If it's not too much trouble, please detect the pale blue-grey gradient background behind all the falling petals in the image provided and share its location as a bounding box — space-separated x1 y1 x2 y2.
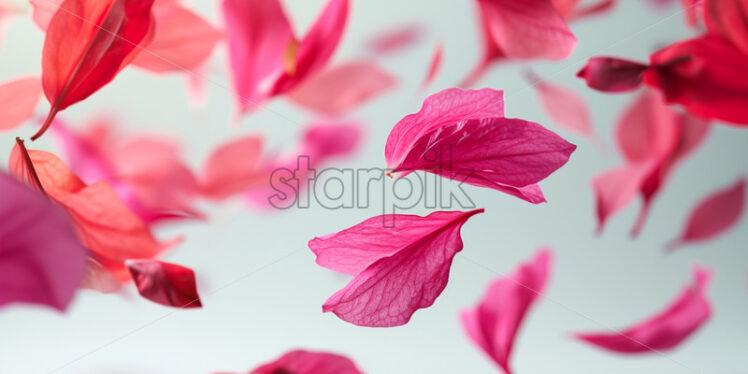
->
0 0 748 374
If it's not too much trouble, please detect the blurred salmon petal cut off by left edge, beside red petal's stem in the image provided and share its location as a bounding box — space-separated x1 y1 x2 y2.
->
0 77 42 130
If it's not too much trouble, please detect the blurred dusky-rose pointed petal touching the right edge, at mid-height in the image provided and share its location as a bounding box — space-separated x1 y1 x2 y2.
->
669 178 746 249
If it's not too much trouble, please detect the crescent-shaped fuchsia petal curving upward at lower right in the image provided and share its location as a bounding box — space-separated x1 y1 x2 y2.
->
576 267 712 354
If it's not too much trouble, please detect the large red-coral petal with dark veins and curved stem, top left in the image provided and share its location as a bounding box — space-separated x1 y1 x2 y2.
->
37 0 153 140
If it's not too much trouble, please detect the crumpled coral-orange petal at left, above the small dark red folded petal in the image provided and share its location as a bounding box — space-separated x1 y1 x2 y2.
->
8 146 165 280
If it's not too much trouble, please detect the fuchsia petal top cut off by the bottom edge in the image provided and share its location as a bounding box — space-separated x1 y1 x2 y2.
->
249 350 363 374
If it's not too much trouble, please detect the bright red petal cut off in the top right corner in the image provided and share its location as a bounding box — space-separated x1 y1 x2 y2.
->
703 0 748 54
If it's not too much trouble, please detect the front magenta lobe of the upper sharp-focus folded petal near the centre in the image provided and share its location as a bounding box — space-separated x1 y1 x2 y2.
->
393 118 576 202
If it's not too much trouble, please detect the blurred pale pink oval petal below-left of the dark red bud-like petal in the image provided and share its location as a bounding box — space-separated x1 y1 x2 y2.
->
531 71 597 140
